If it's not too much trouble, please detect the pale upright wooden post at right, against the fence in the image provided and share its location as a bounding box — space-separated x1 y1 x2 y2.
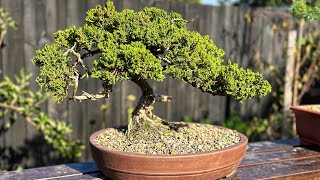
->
281 30 297 138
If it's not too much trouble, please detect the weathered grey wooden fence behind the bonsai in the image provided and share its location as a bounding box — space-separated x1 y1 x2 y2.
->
0 0 294 167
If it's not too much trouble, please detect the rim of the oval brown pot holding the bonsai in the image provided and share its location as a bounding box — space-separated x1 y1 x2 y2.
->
90 125 248 159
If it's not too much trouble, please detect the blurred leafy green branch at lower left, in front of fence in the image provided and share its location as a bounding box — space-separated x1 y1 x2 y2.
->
0 71 84 159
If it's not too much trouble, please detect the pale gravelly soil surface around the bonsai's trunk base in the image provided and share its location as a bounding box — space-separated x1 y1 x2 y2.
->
97 123 240 155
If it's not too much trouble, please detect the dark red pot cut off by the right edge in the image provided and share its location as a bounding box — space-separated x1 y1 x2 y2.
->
290 105 320 146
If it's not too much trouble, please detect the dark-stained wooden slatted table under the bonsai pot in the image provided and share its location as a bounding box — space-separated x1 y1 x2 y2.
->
0 139 320 180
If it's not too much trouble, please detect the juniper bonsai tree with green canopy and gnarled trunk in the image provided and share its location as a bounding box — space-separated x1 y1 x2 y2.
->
33 2 271 141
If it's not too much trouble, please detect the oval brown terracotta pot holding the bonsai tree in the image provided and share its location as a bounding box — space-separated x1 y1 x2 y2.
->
90 125 248 180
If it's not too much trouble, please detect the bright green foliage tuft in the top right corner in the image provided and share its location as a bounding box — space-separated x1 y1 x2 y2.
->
291 0 320 21
